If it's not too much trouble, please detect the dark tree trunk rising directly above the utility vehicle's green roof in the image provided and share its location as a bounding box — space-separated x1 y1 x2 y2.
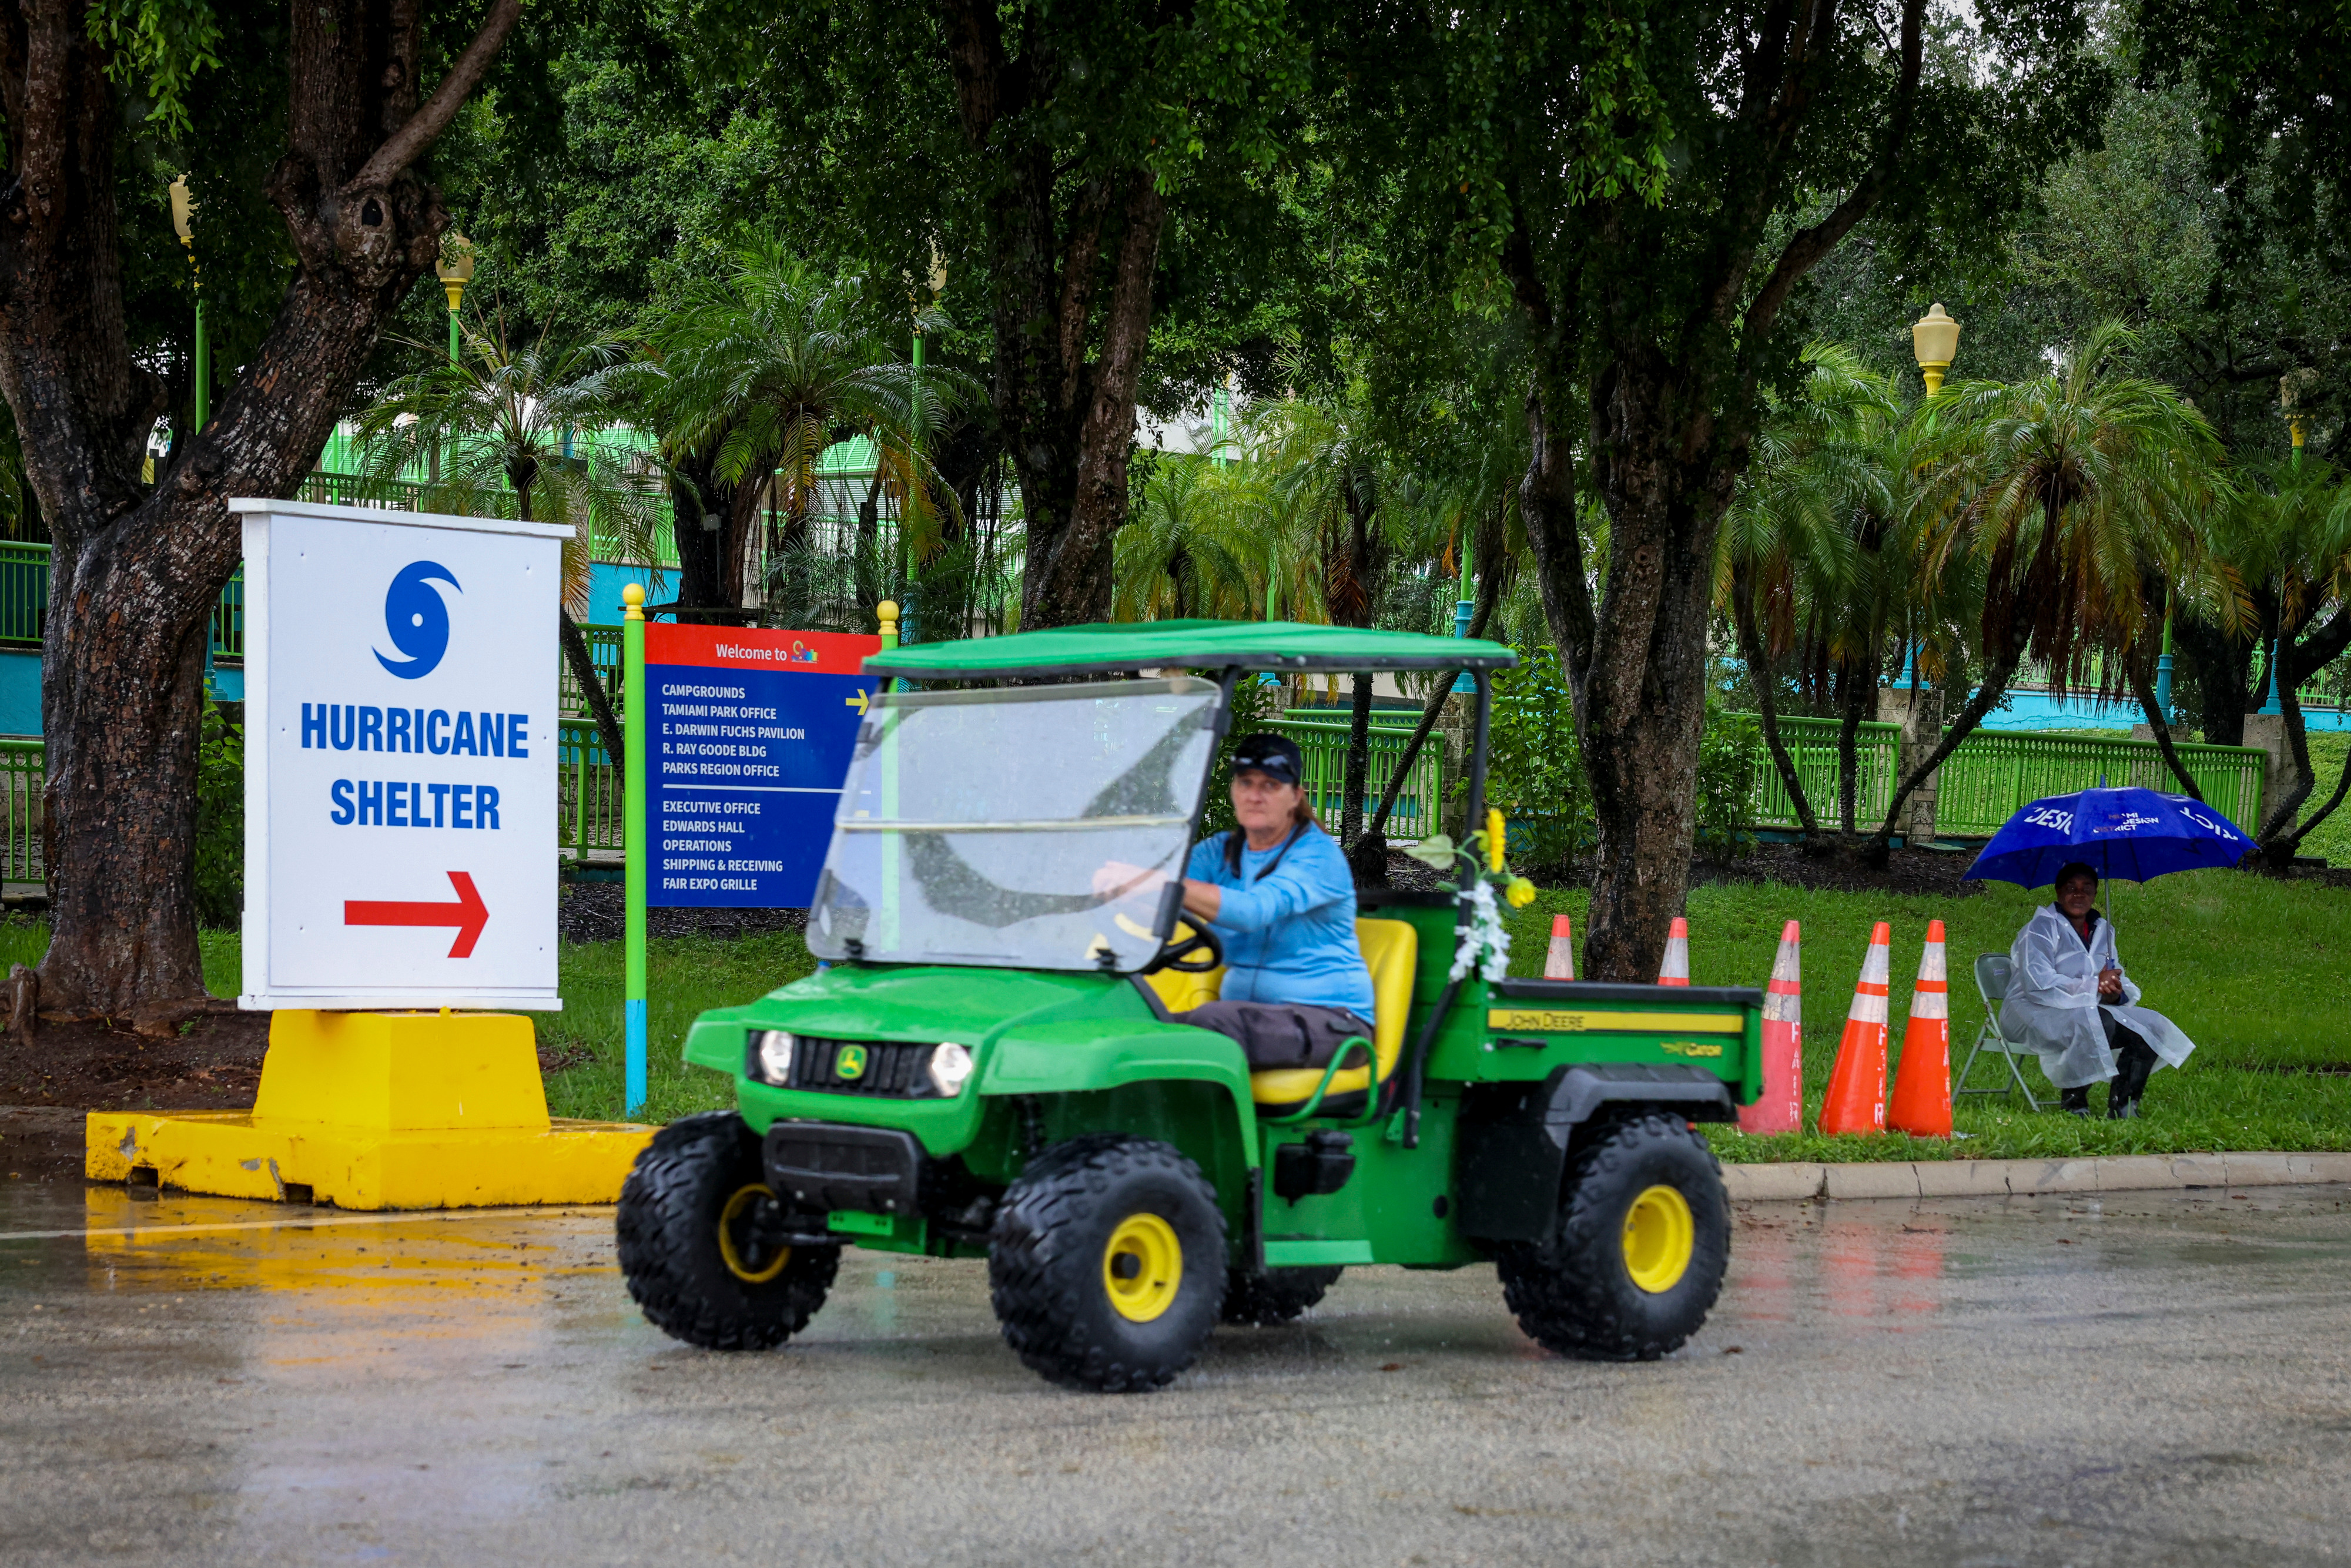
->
945 0 1166 630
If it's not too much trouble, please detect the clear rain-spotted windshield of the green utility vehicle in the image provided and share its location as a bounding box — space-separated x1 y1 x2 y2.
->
809 677 1223 973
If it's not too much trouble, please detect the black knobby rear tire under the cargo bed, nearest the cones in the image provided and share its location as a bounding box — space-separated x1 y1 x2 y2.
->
1495 1114 1730 1361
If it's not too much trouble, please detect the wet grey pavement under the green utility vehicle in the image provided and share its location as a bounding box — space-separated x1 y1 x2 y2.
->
0 1182 2351 1568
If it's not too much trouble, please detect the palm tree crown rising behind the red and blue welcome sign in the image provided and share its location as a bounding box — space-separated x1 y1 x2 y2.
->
628 242 978 618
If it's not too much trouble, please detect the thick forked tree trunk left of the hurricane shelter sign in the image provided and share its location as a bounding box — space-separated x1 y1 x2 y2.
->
0 0 520 1013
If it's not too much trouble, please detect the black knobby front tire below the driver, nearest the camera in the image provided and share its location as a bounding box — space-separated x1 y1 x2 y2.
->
987 1133 1225 1394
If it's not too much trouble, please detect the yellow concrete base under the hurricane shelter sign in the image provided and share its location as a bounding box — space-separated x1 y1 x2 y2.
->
85 1009 654 1208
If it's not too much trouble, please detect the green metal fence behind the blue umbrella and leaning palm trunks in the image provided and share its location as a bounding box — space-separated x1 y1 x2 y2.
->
1756 717 2266 837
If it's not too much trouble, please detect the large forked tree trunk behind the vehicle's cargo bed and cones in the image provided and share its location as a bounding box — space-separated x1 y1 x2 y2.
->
1500 0 1925 980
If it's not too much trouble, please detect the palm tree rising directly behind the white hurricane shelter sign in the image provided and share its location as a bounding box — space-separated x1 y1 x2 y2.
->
357 315 661 766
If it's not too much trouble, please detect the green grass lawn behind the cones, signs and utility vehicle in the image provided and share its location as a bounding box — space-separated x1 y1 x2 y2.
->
46 865 2351 1161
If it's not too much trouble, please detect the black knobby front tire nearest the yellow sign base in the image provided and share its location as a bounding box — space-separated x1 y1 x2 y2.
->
618 1110 842 1349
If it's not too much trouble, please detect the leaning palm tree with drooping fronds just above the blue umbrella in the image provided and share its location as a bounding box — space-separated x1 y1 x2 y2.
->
1869 322 2229 858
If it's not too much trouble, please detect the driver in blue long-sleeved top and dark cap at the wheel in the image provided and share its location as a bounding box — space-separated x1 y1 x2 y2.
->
1096 736 1373 1072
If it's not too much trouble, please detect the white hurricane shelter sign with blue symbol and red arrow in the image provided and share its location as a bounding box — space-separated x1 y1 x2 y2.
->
228 501 571 1011
